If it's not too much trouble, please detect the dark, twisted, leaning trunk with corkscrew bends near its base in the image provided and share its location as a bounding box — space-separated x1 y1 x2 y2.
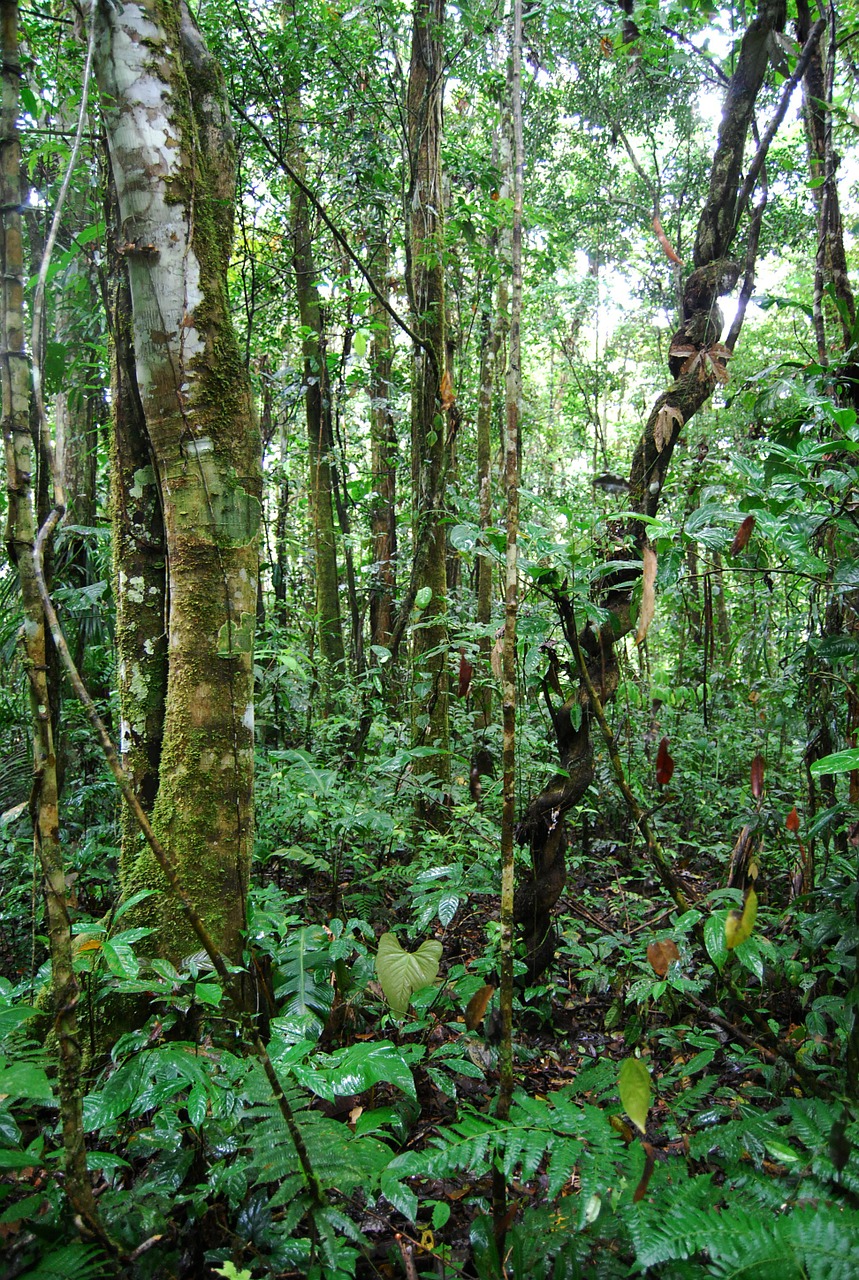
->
516 0 801 978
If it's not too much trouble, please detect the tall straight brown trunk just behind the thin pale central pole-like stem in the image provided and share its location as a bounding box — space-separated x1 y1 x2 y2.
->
407 0 452 820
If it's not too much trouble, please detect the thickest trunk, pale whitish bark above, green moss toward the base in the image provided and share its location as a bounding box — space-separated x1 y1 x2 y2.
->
96 0 261 957
